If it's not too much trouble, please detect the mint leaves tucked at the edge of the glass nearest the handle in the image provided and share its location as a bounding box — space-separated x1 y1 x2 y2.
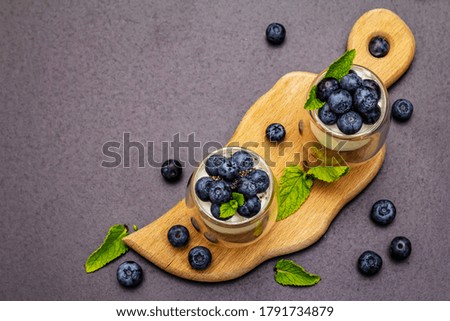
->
305 49 356 110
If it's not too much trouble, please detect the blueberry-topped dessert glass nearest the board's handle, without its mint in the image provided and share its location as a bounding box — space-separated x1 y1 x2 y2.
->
310 65 391 163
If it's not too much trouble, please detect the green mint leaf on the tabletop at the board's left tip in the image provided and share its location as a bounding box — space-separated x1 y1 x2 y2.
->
85 224 128 273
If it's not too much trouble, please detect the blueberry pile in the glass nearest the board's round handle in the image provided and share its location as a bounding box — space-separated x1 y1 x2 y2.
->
316 70 381 135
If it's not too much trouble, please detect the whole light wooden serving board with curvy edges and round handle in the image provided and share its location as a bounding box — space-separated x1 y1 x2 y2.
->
124 9 415 282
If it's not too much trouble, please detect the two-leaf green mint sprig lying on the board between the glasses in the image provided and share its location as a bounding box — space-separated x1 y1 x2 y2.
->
277 165 349 221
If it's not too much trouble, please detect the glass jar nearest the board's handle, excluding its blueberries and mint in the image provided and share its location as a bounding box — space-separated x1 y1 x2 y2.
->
308 65 391 165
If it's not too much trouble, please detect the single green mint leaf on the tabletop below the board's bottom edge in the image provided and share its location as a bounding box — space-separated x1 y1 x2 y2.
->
275 259 320 286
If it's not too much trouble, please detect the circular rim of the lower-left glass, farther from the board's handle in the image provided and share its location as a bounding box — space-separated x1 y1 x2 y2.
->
190 146 275 228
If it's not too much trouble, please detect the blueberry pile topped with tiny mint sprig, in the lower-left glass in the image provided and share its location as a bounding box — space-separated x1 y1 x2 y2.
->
195 150 270 220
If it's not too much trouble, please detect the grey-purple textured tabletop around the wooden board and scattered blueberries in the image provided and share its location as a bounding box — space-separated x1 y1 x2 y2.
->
0 0 450 300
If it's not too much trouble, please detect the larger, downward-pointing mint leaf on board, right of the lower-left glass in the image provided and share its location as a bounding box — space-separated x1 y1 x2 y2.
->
277 165 313 221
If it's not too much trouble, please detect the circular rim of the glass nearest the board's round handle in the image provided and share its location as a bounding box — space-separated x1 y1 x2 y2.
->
308 64 390 140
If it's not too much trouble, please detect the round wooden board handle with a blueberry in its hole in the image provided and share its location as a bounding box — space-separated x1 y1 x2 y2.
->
347 9 416 88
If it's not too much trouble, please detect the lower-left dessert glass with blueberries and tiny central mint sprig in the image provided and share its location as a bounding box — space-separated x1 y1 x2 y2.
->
186 147 277 247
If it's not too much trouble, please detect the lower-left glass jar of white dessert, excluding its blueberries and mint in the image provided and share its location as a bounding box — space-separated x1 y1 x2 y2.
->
185 147 277 247
